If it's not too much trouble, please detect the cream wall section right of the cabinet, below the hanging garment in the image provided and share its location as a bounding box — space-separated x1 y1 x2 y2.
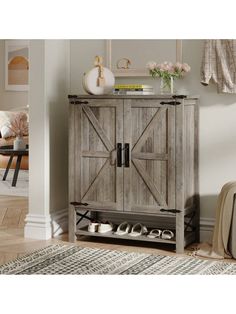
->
183 40 236 218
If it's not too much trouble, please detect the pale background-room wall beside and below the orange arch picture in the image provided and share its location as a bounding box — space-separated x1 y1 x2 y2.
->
0 40 28 110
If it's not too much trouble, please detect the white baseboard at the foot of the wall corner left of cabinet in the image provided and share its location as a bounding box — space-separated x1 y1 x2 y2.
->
24 214 52 240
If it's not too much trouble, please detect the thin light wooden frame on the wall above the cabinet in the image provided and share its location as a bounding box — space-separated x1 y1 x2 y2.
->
106 39 182 77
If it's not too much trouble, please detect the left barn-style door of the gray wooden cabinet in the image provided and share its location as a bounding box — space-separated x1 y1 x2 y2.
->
75 99 123 210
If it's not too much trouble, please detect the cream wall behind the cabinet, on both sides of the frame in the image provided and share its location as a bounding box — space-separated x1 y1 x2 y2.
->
70 40 236 226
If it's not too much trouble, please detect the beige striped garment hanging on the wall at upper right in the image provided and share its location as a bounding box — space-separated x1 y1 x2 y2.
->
201 39 236 93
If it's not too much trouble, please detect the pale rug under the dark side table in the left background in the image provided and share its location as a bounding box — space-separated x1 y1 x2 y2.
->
0 169 29 197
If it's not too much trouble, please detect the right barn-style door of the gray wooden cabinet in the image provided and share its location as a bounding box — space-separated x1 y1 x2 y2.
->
124 99 175 213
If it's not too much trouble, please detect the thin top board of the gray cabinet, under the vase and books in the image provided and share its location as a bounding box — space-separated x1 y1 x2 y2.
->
68 94 199 99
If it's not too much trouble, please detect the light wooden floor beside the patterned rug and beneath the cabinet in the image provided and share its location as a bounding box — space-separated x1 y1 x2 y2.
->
0 196 234 265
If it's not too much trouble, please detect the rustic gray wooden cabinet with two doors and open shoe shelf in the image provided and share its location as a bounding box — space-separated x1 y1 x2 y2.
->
69 95 199 253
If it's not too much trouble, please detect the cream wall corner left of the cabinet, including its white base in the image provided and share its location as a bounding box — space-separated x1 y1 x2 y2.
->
25 40 69 239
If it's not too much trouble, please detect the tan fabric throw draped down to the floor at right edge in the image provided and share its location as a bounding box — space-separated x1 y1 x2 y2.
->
196 181 236 258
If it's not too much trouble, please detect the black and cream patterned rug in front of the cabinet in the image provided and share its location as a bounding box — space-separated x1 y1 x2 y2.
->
0 245 236 275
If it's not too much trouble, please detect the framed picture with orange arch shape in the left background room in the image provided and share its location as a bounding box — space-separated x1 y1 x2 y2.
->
5 40 29 91
